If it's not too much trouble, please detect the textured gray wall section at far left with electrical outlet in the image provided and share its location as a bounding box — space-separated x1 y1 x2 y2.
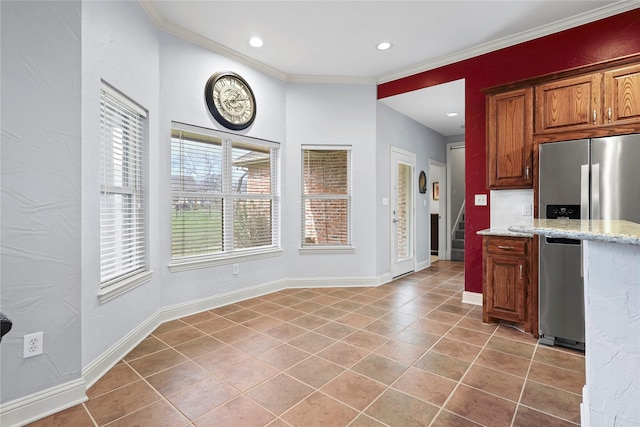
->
0 1 82 401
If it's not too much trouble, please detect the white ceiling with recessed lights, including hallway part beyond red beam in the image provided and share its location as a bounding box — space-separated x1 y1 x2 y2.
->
141 0 640 136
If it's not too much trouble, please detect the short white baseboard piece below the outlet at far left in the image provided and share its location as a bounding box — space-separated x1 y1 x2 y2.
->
0 378 88 427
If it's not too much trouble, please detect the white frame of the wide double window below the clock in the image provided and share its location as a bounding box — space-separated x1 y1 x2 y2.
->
169 122 282 272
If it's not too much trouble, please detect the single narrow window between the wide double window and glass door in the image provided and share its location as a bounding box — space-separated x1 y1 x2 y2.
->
302 146 351 248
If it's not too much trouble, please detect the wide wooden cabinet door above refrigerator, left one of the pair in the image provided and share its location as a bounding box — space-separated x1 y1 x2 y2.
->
535 73 604 133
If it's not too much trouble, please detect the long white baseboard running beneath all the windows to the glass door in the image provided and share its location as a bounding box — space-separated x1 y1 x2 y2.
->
0 273 420 427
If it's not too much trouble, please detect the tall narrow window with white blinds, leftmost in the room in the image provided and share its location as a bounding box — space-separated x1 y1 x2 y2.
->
100 83 147 288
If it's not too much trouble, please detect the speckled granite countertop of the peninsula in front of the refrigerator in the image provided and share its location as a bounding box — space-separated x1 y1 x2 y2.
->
509 219 640 245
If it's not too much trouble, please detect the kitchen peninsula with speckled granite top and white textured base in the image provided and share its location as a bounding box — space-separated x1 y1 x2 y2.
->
509 219 640 427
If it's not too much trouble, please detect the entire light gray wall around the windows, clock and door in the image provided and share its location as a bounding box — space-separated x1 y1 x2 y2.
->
0 1 444 414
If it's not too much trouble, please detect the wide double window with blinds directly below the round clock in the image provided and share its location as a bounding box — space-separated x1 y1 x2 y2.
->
171 123 280 262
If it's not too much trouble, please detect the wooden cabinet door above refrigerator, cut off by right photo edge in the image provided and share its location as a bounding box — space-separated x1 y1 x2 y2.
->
604 64 640 124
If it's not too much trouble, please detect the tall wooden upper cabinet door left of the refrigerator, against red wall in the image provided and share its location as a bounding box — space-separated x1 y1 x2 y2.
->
487 88 533 189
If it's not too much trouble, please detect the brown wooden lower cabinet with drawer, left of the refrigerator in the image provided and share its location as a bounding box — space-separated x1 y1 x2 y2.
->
482 236 537 336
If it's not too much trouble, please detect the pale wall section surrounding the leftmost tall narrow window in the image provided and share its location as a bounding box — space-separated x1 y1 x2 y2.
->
78 1 167 367
